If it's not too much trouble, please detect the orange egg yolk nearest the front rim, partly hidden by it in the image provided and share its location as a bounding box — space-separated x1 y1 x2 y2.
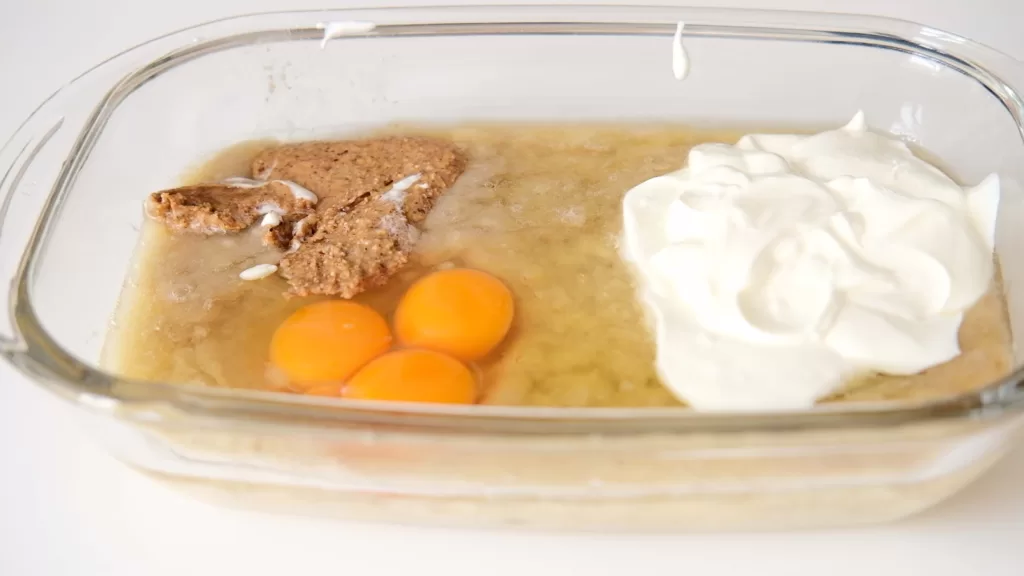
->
342 349 476 404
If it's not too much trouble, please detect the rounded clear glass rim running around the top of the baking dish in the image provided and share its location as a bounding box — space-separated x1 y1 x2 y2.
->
6 5 1024 435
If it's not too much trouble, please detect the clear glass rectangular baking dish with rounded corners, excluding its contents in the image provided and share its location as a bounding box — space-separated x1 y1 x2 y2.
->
0 6 1024 530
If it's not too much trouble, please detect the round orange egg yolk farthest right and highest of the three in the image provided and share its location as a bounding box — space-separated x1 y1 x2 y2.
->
394 269 514 361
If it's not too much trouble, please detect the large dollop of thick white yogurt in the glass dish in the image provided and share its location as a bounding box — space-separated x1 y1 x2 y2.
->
623 113 999 410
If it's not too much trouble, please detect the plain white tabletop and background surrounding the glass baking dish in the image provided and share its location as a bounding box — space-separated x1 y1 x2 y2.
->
0 0 1024 576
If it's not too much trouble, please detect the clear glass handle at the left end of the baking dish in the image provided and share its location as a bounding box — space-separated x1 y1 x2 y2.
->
0 104 63 358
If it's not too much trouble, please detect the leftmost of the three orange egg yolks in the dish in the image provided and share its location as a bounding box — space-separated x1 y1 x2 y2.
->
270 300 391 386
